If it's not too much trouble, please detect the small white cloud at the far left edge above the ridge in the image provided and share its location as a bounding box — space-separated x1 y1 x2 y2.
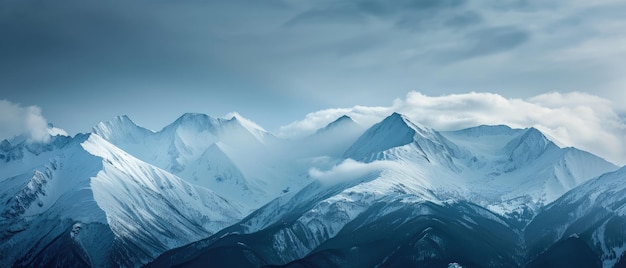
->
0 100 50 142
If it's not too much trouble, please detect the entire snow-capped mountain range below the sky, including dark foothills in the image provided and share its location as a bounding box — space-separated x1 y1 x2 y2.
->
0 113 626 267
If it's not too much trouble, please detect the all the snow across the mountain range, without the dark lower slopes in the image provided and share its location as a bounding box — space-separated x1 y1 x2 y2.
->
0 110 626 266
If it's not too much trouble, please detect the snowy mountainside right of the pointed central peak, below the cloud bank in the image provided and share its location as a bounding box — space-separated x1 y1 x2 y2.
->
442 126 617 222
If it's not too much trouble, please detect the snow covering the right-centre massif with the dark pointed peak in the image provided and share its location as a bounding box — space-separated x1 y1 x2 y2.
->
224 114 616 266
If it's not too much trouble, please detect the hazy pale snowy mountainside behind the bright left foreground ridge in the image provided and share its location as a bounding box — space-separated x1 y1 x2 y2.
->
93 113 307 212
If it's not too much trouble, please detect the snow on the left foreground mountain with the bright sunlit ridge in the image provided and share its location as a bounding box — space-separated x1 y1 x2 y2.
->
0 134 243 266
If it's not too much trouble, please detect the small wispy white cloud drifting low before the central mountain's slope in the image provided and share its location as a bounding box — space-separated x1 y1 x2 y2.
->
309 159 398 184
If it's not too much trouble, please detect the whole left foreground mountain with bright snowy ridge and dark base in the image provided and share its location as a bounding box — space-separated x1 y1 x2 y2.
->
0 134 242 267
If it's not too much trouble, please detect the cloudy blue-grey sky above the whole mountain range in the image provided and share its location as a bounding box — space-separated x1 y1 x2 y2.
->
0 0 626 164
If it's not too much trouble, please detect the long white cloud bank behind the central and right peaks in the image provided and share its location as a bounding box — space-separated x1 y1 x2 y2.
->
279 92 626 165
